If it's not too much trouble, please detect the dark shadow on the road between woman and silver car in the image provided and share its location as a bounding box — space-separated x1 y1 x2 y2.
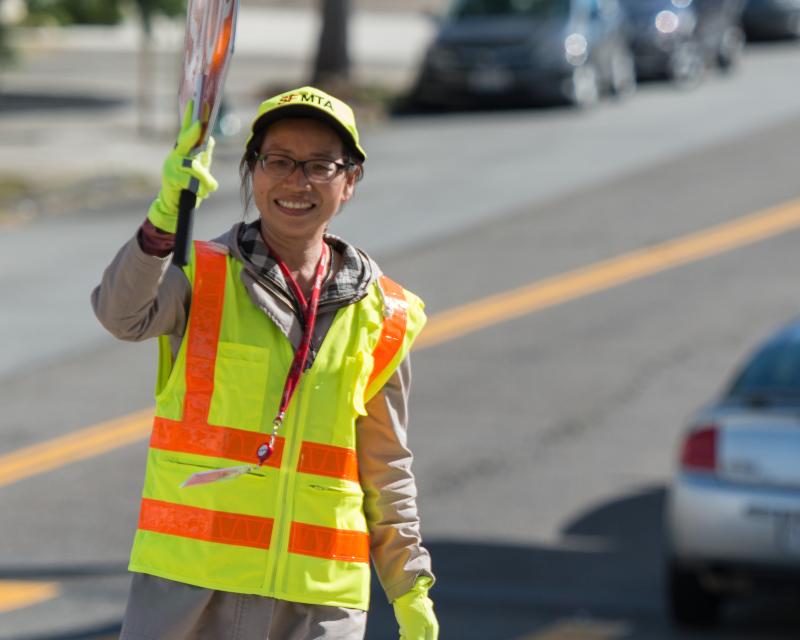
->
367 487 800 640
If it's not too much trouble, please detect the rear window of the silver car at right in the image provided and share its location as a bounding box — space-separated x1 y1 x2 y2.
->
728 341 800 396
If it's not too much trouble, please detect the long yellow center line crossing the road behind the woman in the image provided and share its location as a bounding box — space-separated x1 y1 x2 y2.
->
0 200 800 487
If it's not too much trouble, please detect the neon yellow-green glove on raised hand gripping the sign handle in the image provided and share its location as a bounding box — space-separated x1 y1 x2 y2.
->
147 102 219 233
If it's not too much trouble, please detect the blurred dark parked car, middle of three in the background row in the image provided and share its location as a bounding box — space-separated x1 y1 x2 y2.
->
622 0 745 85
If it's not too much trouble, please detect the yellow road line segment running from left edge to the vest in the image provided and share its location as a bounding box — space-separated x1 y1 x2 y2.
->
0 409 153 487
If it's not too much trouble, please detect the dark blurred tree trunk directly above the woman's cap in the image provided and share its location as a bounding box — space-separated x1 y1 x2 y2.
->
312 0 350 91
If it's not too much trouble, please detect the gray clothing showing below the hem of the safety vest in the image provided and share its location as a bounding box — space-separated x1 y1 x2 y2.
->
120 573 367 640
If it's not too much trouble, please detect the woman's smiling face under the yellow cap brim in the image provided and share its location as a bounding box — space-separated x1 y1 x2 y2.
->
253 118 356 241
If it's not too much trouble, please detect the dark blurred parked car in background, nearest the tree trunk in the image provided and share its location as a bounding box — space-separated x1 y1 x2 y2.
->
411 0 636 107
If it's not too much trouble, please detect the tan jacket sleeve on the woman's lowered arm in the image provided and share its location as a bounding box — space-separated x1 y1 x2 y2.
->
357 358 434 602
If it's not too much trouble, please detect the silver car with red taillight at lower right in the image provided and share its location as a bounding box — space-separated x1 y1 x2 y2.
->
665 320 800 625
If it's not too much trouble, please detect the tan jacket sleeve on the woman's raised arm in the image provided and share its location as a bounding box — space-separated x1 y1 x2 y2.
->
92 232 191 341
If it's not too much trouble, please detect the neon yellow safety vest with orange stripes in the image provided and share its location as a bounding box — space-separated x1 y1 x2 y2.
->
129 242 425 610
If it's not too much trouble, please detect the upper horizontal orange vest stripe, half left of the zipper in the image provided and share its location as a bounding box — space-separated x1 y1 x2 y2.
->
150 416 284 468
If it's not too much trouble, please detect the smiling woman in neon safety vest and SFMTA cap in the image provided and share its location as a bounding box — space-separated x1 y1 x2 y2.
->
92 87 438 640
